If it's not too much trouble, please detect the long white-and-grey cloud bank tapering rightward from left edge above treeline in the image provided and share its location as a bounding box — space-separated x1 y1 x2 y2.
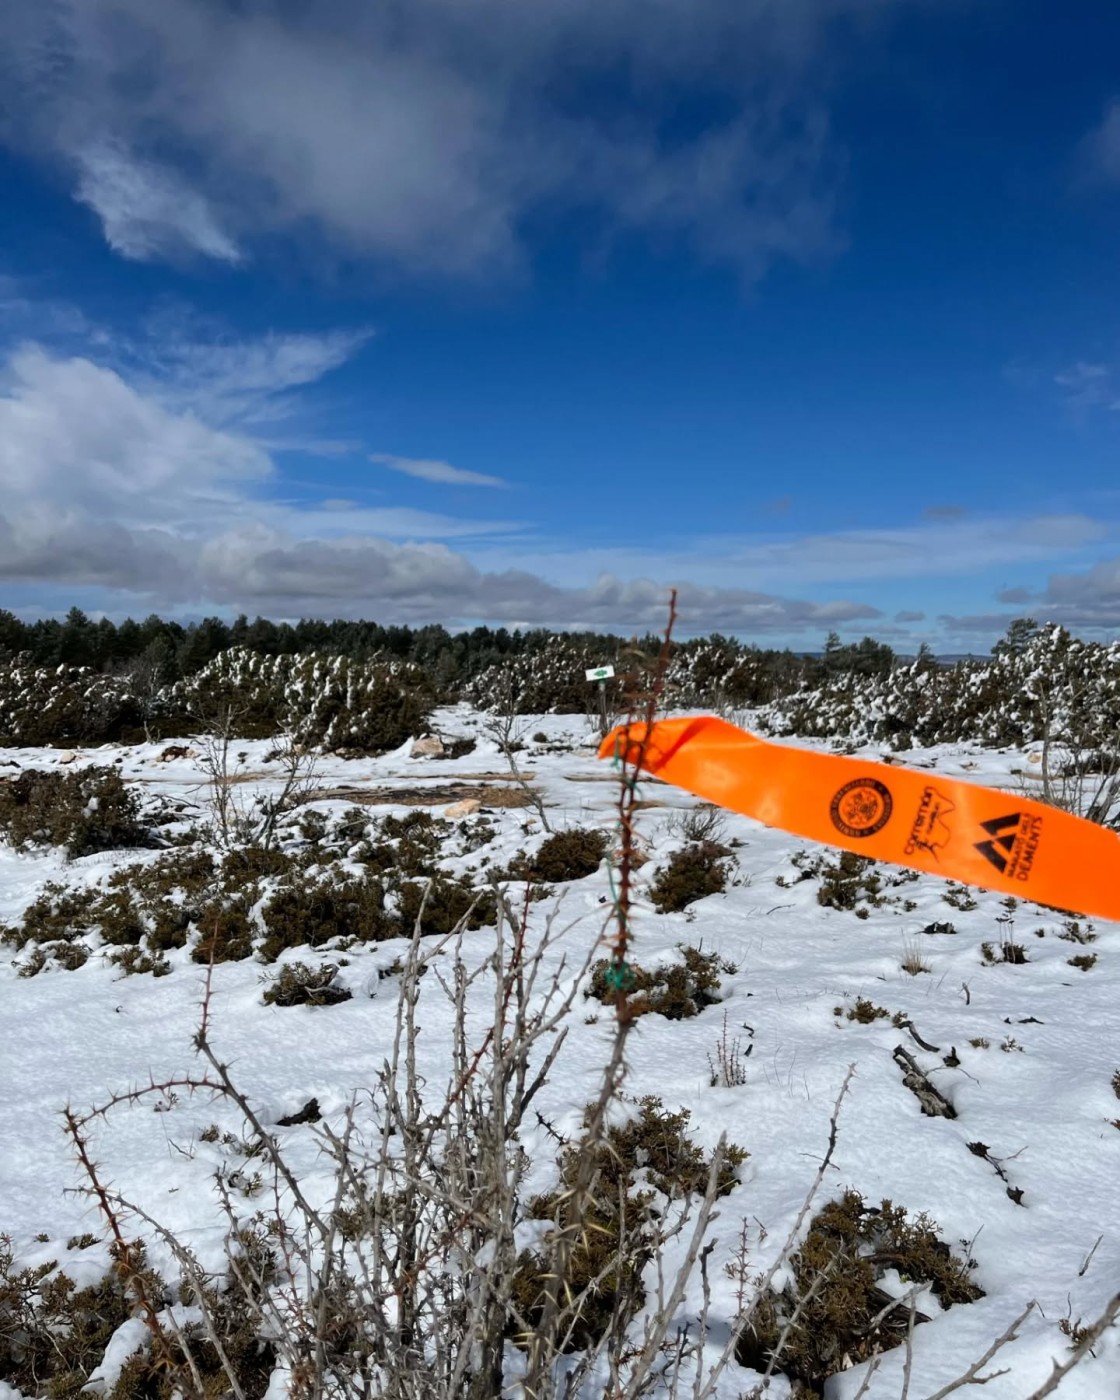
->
0 336 879 634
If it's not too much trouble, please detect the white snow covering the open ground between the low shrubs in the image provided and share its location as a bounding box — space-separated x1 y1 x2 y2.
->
0 708 1120 1400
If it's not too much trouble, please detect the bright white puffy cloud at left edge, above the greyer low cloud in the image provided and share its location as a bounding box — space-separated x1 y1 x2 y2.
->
0 337 518 543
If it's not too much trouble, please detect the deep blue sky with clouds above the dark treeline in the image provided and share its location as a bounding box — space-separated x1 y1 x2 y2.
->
0 0 1120 651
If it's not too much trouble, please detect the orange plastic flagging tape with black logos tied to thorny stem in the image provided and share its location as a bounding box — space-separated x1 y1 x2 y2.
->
599 715 1120 920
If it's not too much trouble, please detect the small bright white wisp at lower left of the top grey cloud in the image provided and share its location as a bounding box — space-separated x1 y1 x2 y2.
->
74 141 242 263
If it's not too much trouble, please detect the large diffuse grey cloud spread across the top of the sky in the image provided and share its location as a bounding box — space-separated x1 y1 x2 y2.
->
0 0 900 280
